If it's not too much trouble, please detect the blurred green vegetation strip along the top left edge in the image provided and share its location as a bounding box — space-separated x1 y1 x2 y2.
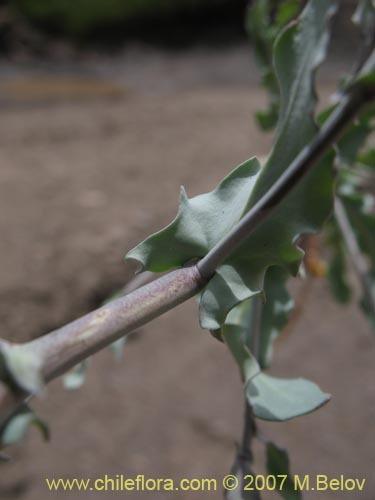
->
9 0 246 38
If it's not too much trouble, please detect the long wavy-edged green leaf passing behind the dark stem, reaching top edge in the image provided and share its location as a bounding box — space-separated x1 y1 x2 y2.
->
201 0 333 329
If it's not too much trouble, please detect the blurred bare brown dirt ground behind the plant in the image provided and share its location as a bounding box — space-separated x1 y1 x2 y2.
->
0 48 375 500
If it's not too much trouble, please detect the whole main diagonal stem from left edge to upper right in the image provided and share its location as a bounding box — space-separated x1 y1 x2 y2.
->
0 75 375 422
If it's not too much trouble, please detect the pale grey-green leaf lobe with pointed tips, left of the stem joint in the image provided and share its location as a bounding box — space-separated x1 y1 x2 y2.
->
126 158 260 272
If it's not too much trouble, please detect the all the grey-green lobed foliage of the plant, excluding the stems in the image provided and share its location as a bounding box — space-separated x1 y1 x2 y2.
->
0 4 375 500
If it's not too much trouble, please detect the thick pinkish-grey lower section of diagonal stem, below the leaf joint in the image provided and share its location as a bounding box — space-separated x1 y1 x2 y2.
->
0 266 206 420
